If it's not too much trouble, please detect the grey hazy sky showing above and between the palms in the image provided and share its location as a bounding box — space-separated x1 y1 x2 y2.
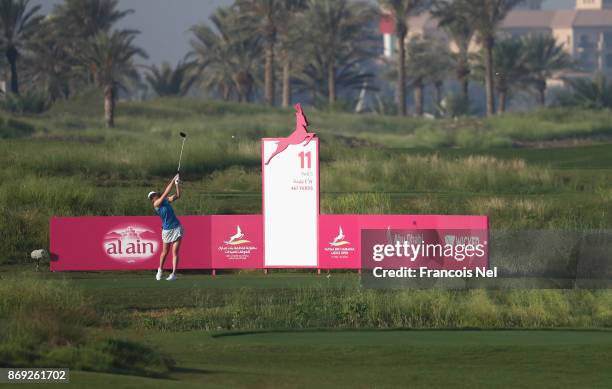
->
32 0 575 64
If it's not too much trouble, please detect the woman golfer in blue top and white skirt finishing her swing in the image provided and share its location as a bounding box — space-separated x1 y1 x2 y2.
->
147 174 183 281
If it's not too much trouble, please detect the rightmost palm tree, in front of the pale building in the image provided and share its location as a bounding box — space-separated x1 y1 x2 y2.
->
523 34 572 106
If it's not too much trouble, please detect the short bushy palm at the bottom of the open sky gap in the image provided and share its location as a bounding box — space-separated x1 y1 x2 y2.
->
145 62 195 96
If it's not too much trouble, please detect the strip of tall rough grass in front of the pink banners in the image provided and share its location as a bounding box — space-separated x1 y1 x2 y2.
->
129 288 612 331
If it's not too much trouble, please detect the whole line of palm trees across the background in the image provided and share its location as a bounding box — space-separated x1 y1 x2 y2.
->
0 0 610 126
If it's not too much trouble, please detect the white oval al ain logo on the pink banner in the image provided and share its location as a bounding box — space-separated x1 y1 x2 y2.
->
103 224 159 263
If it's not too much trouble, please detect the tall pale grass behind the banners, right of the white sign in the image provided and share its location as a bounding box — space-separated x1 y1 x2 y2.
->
321 154 556 193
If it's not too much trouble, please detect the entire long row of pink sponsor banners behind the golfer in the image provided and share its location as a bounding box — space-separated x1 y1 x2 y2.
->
50 215 488 271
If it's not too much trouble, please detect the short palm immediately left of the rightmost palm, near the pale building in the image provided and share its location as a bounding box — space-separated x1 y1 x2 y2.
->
493 39 528 114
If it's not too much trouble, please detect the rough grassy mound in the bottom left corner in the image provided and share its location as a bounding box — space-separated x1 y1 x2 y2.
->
0 277 173 376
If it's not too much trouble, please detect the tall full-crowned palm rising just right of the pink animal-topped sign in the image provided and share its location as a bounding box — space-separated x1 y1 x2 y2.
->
302 0 372 106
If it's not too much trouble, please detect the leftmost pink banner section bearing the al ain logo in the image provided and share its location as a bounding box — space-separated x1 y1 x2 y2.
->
50 216 211 271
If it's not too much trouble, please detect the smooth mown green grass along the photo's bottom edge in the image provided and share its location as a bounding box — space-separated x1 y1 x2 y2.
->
28 331 612 389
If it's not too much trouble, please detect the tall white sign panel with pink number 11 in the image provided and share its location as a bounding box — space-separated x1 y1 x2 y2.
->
262 138 319 267
